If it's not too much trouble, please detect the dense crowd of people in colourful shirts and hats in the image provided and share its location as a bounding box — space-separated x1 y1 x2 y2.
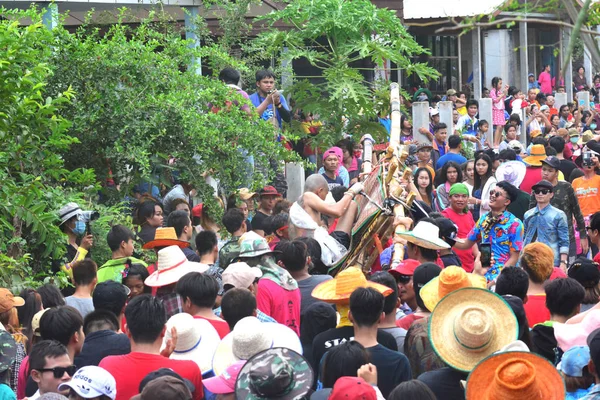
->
5 69 600 400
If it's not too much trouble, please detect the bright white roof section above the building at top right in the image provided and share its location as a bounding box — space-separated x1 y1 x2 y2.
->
404 0 505 20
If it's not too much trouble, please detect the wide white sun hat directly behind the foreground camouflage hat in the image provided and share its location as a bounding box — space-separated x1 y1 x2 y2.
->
212 317 302 376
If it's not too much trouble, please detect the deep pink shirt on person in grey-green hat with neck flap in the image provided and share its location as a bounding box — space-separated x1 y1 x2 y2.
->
256 278 302 336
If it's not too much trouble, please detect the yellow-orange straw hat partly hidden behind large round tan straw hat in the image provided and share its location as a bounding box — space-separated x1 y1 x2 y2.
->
419 265 487 311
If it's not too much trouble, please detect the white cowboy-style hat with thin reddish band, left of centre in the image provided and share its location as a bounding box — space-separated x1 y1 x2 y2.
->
144 246 208 287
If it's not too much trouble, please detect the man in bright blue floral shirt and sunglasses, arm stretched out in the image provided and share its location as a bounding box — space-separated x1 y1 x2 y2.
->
454 181 523 282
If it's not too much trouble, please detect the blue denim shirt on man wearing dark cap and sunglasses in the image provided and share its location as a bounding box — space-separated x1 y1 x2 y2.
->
523 204 569 266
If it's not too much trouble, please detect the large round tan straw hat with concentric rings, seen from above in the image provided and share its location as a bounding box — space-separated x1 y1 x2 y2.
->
429 288 519 372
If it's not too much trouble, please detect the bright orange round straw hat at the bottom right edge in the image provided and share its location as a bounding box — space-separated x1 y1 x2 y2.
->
466 352 566 400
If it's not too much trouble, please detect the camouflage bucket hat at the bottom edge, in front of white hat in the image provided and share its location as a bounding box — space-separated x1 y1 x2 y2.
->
235 347 314 400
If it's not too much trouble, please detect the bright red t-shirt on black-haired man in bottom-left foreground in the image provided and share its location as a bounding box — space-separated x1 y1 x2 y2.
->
99 352 204 400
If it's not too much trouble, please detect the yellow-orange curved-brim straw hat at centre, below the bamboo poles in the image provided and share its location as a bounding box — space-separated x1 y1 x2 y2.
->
311 267 392 303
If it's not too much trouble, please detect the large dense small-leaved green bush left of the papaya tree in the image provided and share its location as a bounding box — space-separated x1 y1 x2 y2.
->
44 9 286 200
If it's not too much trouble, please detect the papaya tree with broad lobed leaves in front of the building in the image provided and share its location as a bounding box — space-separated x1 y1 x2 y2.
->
252 0 438 143
